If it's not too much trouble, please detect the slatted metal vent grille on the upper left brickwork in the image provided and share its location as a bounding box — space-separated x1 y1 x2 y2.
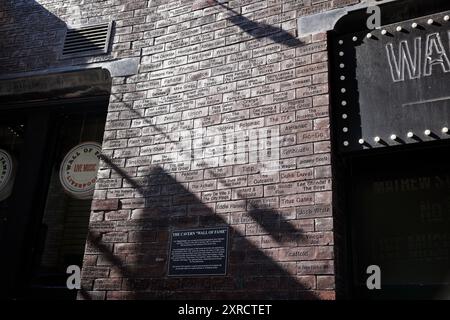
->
62 22 112 58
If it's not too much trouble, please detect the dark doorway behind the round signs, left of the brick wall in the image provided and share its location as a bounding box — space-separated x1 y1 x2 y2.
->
0 96 109 299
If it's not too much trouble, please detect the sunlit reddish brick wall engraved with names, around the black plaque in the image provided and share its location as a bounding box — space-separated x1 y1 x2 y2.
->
0 0 364 299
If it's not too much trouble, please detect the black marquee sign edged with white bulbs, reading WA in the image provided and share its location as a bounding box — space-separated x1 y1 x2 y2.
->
333 13 450 152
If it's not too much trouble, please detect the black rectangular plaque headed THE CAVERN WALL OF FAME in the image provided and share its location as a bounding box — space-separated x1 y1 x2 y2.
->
169 227 228 276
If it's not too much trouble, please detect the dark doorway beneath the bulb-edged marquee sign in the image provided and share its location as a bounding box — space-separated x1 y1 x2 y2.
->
347 143 450 299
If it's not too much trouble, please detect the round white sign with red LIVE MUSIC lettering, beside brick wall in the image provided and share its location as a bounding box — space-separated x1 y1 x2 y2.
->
59 142 102 199
